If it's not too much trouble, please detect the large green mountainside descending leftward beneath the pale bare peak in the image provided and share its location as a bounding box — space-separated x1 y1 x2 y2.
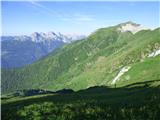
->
2 25 160 93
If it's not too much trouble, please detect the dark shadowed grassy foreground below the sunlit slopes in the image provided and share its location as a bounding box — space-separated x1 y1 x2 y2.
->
2 80 160 120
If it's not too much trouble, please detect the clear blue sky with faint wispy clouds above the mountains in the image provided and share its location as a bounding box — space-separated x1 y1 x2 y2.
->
1 1 160 35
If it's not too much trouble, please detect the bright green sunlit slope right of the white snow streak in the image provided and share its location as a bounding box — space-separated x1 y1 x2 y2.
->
116 56 160 86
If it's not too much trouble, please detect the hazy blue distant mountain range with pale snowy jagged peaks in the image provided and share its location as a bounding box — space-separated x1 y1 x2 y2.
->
1 32 85 68
